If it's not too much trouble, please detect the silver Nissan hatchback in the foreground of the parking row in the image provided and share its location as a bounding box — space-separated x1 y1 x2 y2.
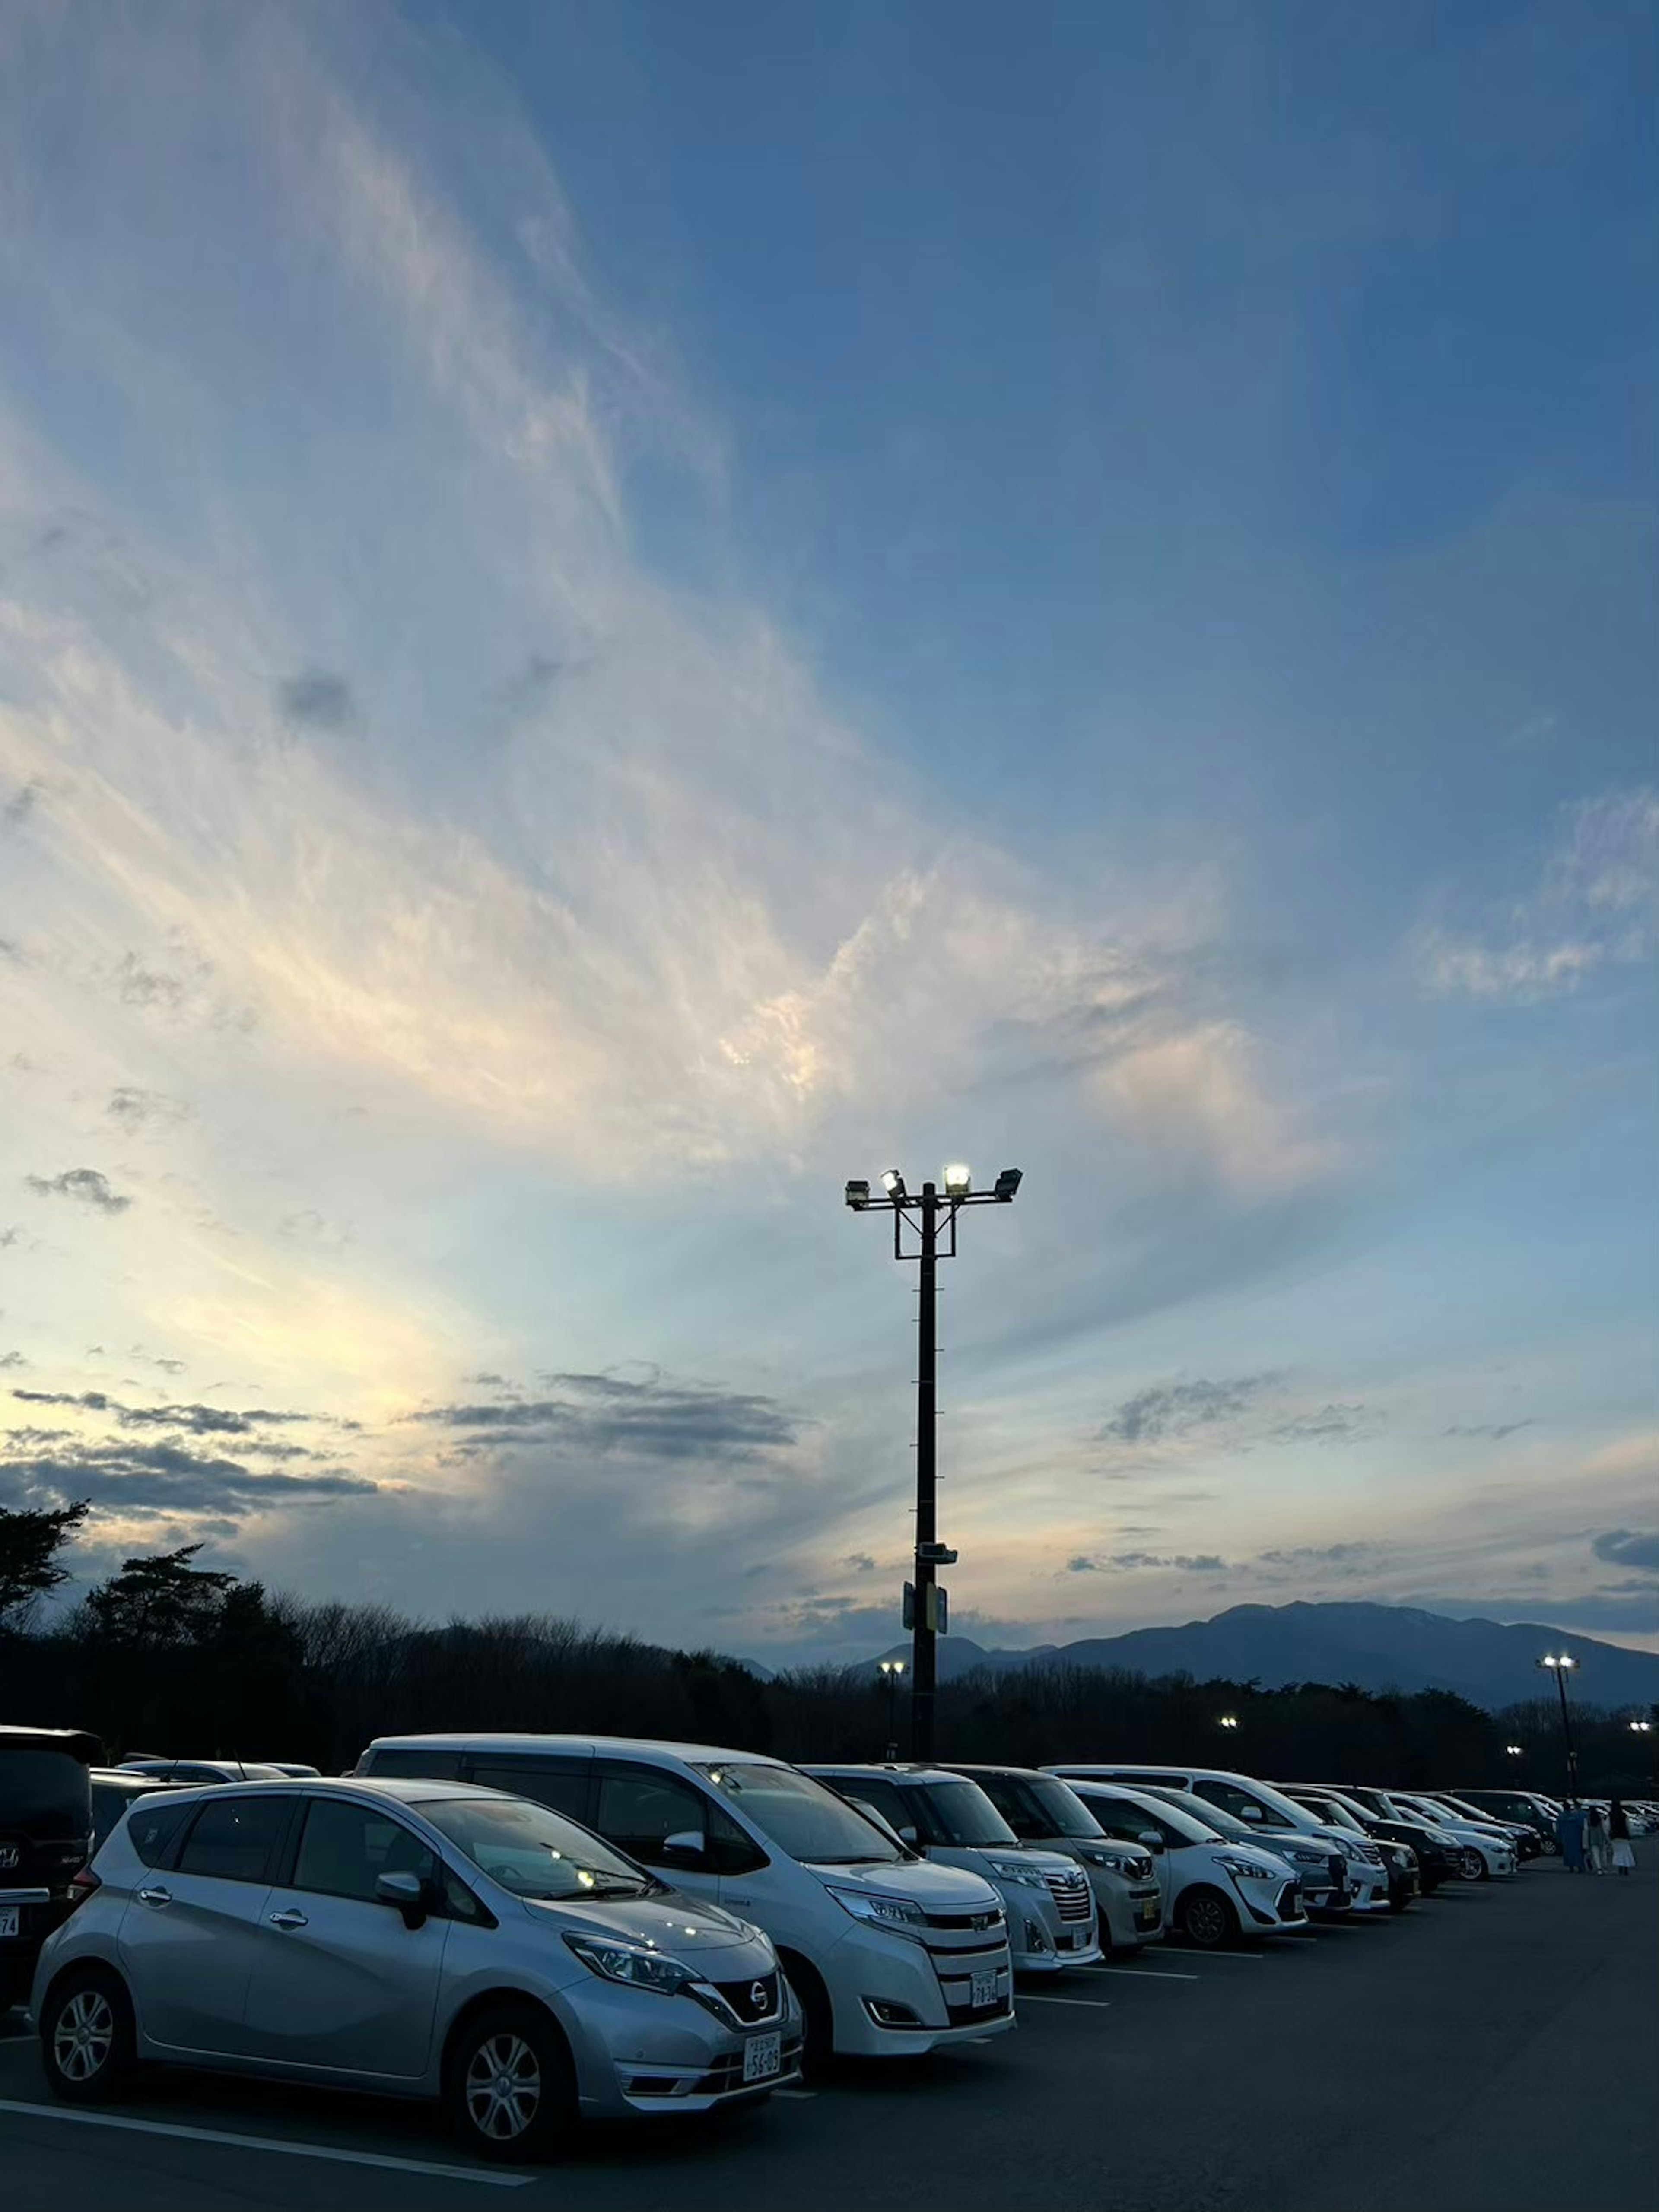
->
31 1780 801 2159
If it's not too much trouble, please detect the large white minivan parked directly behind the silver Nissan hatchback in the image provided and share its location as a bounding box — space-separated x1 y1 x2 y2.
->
356 1734 1013 2064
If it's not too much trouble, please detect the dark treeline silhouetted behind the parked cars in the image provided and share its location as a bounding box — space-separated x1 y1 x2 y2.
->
0 1509 1653 1794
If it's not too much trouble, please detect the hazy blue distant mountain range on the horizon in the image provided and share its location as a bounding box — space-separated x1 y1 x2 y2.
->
827 1604 1659 1712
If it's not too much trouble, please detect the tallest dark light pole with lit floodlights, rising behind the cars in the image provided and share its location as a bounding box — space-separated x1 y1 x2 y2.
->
847 1166 1022 1758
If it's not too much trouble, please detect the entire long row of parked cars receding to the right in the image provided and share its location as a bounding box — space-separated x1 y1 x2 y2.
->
0 1730 1637 2159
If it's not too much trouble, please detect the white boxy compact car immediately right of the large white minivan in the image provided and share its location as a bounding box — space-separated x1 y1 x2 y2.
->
801 1763 1100 1973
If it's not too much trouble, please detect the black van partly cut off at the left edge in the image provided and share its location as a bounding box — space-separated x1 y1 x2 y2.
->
0 1723 104 2013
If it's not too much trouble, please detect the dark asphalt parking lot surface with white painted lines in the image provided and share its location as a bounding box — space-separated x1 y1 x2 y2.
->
0 1849 1659 2212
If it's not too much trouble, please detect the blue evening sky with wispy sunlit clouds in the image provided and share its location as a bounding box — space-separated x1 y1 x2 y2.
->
0 0 1659 1663
